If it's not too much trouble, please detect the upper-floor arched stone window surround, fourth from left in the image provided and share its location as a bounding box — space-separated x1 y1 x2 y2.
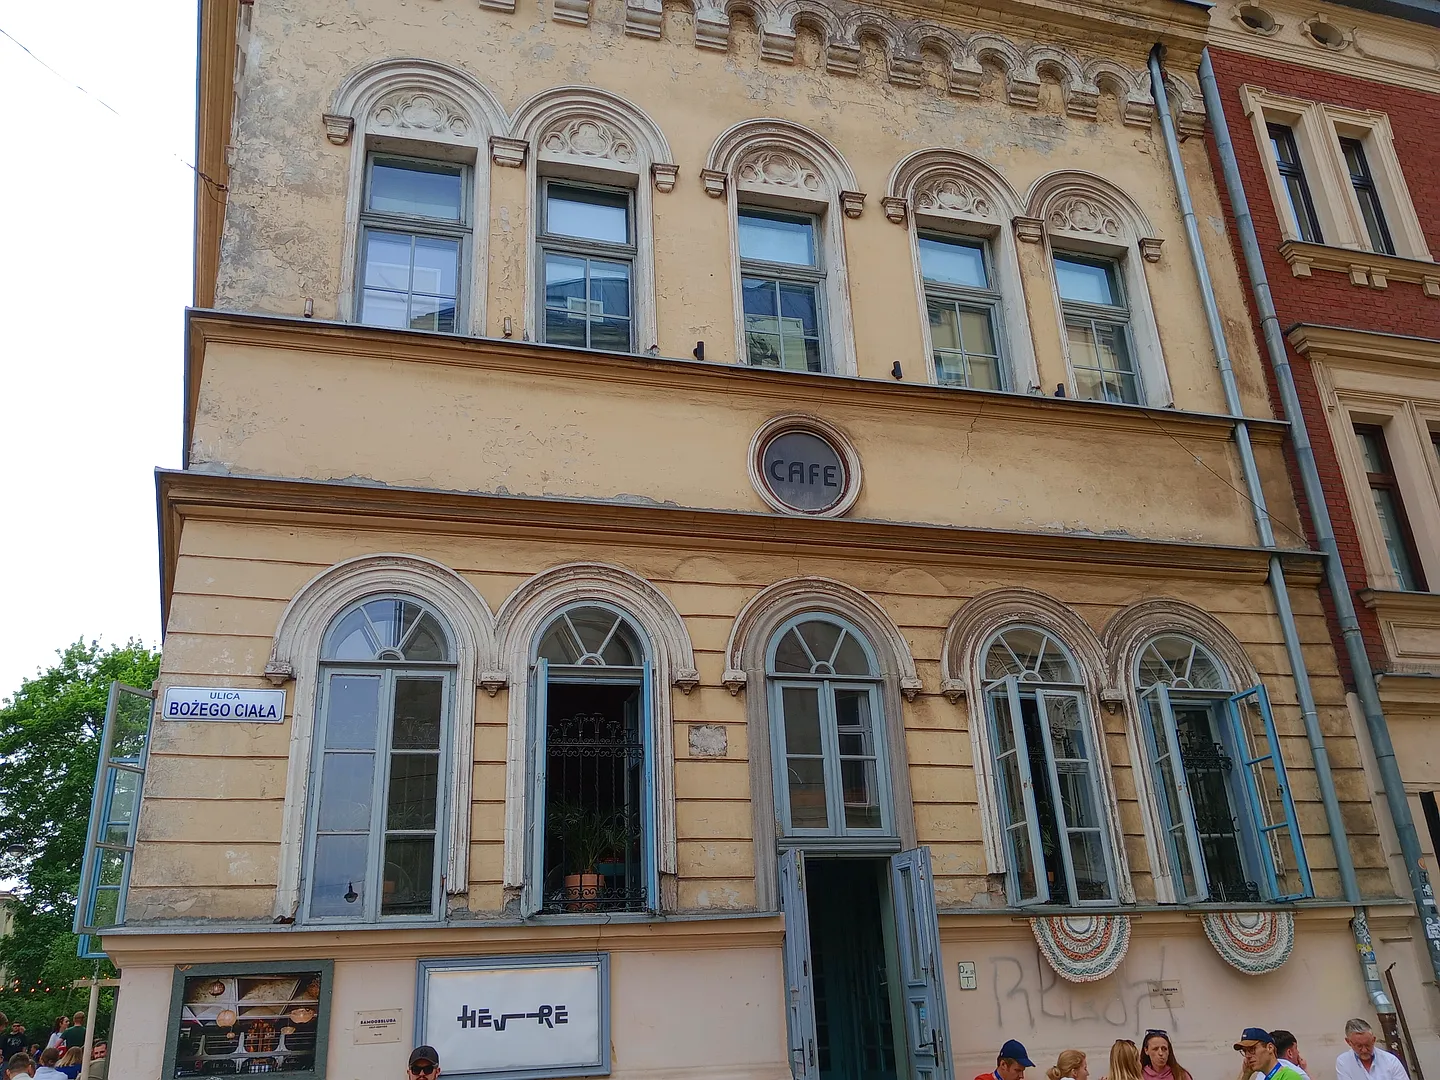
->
880 147 1040 390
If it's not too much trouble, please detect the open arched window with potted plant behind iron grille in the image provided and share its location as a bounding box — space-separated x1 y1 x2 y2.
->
523 605 660 916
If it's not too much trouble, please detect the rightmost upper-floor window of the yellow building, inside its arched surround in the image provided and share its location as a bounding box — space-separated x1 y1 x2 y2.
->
1056 252 1140 405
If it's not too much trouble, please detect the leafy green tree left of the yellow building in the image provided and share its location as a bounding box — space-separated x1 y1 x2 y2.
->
0 639 160 1043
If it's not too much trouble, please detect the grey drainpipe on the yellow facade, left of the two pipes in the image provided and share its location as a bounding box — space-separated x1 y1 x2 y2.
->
1151 45 1359 904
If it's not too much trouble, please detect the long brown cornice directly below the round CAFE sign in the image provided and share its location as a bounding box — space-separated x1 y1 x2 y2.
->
156 469 1322 618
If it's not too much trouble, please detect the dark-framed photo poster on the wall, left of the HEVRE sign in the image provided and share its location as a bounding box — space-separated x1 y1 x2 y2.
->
161 960 336 1080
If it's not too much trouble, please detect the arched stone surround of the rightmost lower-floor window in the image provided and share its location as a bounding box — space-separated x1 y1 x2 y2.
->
1103 596 1260 903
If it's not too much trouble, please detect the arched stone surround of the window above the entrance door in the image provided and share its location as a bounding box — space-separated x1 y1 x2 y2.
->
724 577 923 912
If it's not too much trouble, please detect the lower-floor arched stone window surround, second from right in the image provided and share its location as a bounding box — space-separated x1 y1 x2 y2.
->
940 588 1135 903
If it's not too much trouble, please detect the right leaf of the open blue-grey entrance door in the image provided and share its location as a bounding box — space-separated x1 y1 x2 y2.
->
890 848 955 1080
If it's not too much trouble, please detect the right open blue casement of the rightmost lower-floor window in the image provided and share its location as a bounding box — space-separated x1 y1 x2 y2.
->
1227 685 1315 900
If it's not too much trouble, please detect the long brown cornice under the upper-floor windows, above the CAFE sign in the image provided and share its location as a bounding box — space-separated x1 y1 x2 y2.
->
181 310 1287 467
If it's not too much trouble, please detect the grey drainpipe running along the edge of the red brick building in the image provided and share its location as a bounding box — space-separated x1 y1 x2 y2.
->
1200 49 1440 1012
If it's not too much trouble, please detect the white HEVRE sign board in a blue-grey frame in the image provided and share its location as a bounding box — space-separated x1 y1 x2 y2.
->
416 955 611 1077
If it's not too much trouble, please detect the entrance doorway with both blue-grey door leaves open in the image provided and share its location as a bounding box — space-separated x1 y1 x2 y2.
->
779 848 953 1080
